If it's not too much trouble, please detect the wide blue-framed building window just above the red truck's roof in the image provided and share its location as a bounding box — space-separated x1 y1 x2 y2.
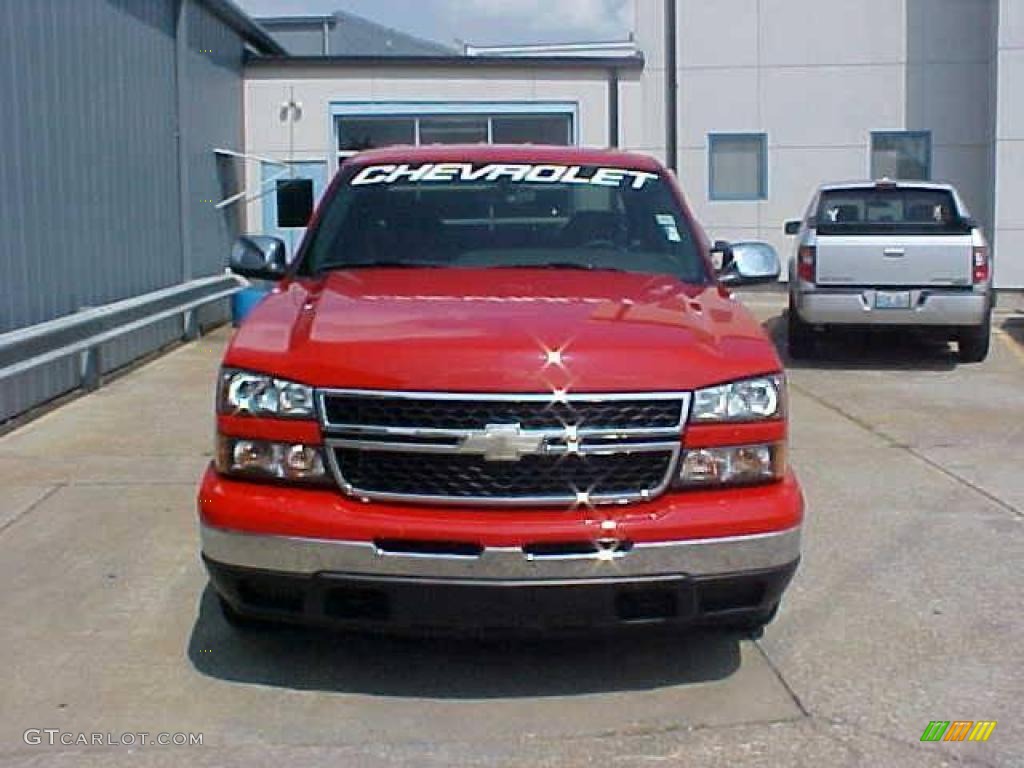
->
335 104 575 160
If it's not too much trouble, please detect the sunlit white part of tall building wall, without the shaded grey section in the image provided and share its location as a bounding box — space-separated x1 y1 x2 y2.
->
637 0 905 268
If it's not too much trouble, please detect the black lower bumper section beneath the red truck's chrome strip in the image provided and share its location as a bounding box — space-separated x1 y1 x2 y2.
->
206 559 797 634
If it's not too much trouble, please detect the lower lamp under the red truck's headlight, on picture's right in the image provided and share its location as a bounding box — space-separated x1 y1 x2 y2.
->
677 442 785 487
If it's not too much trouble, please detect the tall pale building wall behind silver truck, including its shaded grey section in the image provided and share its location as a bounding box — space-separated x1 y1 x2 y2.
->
627 0 1011 286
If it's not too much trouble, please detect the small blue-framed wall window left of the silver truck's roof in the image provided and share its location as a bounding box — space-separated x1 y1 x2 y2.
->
708 133 768 200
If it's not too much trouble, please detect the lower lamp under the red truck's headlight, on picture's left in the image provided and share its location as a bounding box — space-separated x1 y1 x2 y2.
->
216 435 330 483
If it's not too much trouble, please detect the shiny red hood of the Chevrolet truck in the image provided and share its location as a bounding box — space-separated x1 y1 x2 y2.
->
224 269 781 392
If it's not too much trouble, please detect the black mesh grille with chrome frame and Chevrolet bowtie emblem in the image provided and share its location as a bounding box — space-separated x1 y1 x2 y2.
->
317 390 689 505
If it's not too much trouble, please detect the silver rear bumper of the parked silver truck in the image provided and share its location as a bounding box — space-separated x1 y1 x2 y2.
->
794 288 990 326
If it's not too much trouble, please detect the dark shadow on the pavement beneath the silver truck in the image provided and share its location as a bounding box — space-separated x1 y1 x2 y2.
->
761 312 958 371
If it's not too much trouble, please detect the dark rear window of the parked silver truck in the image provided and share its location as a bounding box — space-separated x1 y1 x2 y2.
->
816 187 970 234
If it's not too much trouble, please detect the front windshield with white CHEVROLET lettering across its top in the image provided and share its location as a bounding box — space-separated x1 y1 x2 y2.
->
299 163 708 283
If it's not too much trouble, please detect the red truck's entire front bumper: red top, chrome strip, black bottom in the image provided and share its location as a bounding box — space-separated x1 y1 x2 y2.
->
200 471 803 632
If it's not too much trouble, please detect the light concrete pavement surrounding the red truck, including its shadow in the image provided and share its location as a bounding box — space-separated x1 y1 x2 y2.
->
0 303 1024 766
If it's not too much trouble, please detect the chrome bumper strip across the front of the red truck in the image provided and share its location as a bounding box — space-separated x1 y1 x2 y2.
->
200 525 800 581
